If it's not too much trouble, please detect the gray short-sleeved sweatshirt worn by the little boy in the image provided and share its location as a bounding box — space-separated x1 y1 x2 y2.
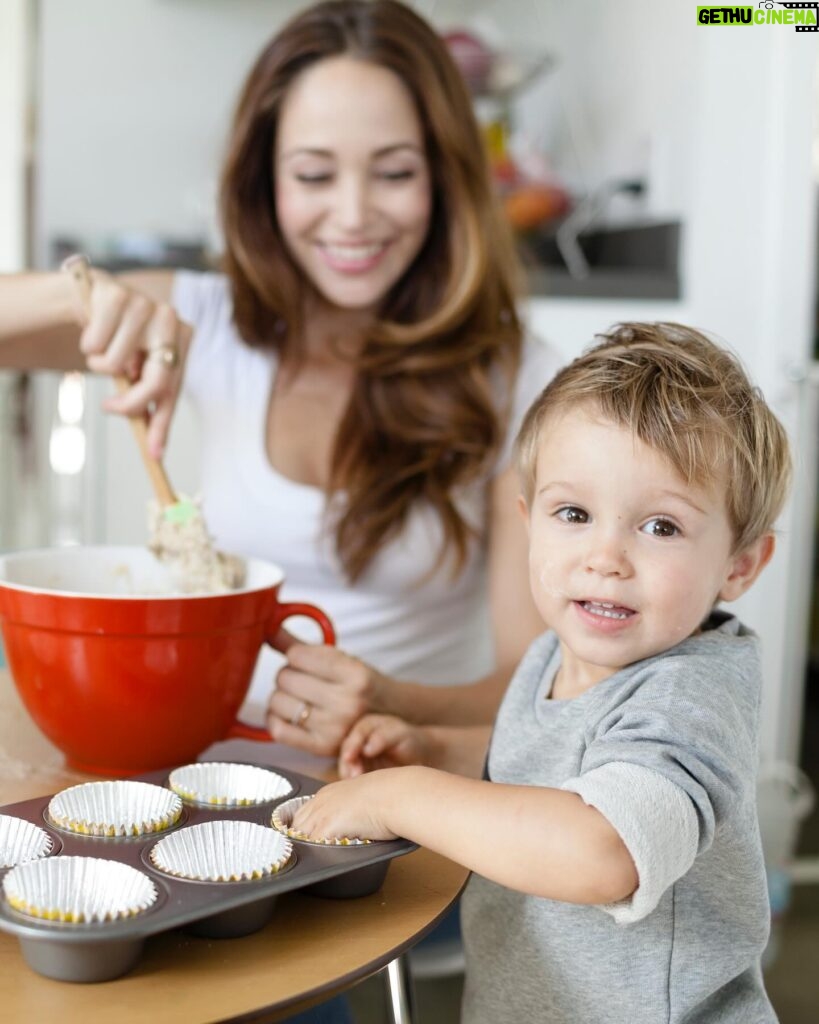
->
462 612 776 1024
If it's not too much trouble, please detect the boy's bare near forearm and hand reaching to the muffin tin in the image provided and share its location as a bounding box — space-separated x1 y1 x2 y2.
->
294 766 639 903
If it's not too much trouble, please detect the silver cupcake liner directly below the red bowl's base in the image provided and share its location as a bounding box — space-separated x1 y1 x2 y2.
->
48 780 182 838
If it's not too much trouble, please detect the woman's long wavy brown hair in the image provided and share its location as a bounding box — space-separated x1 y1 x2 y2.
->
221 0 521 580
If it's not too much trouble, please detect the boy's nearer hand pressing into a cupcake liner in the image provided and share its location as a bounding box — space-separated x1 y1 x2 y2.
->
292 771 397 839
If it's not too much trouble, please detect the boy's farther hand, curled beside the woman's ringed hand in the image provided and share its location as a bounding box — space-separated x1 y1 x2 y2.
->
339 715 433 778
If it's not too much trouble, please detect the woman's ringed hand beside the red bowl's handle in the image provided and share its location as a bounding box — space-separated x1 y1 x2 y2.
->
267 642 392 757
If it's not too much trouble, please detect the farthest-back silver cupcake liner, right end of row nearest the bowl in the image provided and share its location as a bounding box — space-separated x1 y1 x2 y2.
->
168 761 293 807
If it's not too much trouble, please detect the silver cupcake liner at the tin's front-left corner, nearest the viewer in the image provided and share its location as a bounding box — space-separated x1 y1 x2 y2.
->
3 857 157 924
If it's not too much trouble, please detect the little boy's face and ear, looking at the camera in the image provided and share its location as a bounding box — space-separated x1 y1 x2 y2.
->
524 409 773 688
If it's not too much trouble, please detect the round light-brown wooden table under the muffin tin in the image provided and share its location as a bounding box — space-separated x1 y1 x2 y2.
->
0 671 468 1024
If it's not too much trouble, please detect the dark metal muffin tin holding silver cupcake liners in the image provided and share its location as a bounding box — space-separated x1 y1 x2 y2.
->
0 758 415 982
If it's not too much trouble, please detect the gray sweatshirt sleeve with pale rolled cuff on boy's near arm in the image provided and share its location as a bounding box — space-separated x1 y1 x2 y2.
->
562 655 758 924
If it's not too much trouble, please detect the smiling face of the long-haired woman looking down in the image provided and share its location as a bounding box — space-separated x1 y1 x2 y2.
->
274 56 432 311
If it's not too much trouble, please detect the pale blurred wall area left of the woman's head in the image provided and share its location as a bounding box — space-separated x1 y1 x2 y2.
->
38 0 297 254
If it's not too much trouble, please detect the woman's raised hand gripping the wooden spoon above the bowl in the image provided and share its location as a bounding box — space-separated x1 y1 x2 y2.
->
72 269 192 458
